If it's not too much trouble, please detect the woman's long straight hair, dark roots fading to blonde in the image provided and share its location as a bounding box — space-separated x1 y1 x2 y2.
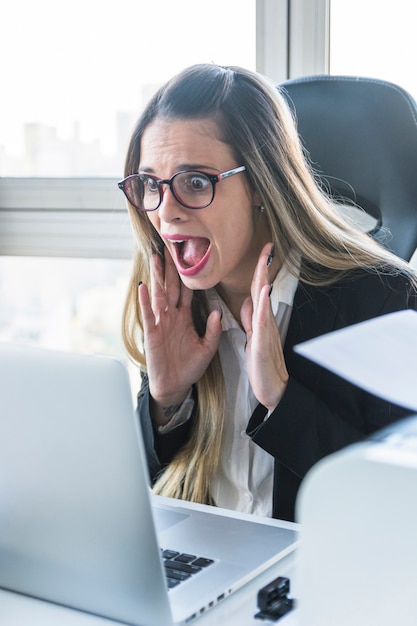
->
123 64 417 503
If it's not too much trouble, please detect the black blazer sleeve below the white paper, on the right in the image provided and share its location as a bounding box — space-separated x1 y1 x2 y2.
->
247 370 410 478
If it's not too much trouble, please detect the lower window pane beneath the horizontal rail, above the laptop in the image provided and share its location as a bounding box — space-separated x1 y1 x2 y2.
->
0 257 131 358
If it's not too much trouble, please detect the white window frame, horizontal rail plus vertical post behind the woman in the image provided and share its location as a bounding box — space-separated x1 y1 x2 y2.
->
0 0 330 259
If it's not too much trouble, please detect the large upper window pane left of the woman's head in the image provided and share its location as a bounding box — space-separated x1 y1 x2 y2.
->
0 0 256 177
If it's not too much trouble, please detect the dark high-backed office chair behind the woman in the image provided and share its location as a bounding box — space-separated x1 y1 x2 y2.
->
279 75 417 261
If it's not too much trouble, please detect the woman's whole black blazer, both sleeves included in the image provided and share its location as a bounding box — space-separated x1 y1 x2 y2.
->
138 271 417 520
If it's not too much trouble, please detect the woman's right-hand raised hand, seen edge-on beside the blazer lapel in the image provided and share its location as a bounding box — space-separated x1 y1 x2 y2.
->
240 243 288 410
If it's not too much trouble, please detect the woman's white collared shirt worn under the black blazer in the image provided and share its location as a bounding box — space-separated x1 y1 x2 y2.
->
159 264 298 517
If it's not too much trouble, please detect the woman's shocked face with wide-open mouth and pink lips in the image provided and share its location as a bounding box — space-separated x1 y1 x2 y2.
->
139 119 270 292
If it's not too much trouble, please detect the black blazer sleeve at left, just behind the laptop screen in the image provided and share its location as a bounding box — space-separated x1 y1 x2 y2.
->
136 373 196 481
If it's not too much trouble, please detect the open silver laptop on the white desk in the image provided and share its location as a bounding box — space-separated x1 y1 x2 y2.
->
0 344 297 626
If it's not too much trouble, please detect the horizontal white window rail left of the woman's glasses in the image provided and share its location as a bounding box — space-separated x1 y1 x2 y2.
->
0 178 133 259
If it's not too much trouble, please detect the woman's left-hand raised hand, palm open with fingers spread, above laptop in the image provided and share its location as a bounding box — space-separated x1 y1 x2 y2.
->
138 247 221 425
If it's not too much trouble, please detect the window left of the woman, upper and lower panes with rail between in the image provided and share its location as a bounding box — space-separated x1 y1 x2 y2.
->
0 0 264 380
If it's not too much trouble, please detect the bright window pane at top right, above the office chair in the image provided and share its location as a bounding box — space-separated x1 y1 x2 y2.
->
330 0 417 98
